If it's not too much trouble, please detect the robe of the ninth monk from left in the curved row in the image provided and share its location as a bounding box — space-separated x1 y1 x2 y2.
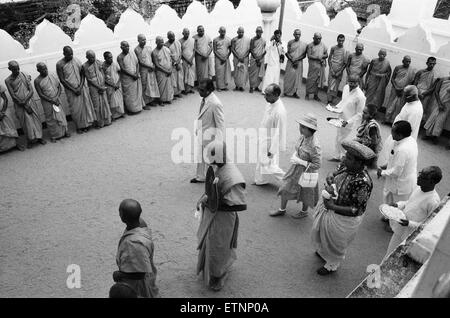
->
152 46 174 102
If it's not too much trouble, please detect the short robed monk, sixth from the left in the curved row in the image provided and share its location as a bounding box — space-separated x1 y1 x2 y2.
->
102 51 125 120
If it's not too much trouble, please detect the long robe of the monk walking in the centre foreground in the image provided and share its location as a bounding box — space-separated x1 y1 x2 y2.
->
197 163 247 285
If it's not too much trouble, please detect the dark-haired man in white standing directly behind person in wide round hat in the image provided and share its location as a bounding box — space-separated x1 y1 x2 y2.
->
377 120 418 212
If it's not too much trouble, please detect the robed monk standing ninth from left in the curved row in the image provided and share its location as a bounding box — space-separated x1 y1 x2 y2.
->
152 36 174 104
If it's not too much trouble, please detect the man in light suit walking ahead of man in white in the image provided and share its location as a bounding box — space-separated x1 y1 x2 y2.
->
191 79 225 183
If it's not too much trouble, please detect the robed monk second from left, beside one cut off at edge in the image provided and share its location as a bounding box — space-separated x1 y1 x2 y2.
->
5 61 47 148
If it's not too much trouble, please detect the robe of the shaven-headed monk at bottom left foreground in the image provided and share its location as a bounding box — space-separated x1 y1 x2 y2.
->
116 227 159 298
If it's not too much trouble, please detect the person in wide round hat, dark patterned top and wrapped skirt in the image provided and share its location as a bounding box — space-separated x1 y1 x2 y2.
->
311 140 375 275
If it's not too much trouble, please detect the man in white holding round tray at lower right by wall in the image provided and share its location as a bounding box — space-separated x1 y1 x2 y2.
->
385 166 442 257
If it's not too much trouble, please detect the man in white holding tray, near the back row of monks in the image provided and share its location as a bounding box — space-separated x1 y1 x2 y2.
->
327 75 366 162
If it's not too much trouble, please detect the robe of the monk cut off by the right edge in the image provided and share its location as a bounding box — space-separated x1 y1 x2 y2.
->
424 77 450 137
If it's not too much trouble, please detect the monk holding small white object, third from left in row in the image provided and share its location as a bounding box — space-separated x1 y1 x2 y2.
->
34 63 70 142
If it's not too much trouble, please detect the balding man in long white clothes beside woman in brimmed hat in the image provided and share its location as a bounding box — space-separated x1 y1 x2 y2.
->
255 84 287 186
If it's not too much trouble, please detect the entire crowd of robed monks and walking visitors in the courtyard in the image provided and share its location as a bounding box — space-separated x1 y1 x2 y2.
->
0 26 450 297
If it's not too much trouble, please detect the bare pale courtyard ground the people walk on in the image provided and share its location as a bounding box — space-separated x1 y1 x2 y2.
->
0 85 450 297
